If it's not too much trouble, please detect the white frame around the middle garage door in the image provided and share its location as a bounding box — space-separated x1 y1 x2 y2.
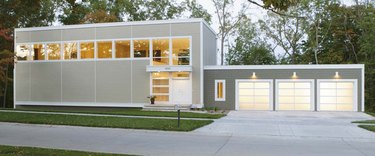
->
275 79 315 111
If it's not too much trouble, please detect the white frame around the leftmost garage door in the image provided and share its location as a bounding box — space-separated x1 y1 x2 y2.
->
235 79 273 111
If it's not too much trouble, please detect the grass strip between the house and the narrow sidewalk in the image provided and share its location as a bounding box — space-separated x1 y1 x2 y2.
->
7 107 225 119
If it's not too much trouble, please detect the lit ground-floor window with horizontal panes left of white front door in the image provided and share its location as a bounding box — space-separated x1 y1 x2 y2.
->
152 72 169 103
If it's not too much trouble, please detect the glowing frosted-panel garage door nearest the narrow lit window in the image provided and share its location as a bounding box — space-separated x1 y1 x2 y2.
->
237 81 272 110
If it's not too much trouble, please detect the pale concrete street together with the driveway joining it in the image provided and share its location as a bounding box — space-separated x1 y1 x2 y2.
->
0 111 375 156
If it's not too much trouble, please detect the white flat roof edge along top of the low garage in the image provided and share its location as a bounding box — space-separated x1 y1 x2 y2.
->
204 64 365 70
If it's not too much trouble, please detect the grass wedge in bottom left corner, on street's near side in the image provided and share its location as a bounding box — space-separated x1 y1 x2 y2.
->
0 145 130 156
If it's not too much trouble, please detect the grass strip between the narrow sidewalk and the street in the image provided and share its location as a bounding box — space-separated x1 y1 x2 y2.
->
0 112 213 131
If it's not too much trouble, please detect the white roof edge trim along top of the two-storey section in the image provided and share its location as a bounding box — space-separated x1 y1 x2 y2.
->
14 18 216 35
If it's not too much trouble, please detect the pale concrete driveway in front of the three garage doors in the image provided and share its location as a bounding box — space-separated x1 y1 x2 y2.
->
195 111 375 139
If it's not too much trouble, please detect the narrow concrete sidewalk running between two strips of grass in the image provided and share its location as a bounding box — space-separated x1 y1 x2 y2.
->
0 110 214 120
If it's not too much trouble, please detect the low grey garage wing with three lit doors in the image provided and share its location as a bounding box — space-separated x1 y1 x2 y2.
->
204 65 364 111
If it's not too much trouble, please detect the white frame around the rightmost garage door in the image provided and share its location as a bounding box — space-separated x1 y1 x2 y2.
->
317 79 358 112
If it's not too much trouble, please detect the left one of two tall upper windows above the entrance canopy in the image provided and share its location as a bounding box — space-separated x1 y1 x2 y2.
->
152 39 169 66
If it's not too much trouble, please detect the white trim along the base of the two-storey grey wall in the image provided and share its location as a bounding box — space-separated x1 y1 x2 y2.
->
15 101 147 107
